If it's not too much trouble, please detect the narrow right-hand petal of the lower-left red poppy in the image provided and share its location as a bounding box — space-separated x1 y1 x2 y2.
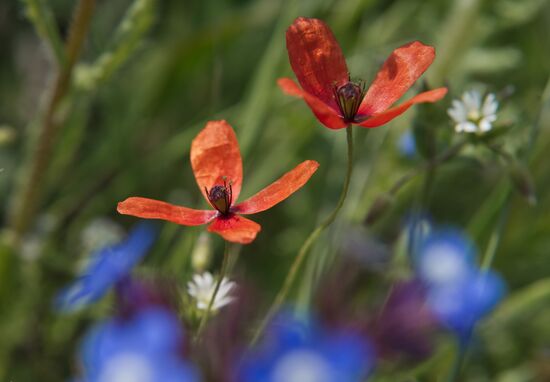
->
234 160 319 214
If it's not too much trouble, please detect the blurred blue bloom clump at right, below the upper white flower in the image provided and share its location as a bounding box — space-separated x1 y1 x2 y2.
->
414 230 506 341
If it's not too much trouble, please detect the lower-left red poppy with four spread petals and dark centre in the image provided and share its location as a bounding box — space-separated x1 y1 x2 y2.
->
117 121 319 244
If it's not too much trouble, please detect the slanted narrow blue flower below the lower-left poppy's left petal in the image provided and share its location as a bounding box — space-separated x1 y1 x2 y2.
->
54 223 156 312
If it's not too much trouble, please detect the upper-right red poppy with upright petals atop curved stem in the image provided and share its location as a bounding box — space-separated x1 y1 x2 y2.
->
278 17 447 129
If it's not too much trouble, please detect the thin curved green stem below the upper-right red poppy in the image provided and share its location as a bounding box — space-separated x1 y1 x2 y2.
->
251 125 353 345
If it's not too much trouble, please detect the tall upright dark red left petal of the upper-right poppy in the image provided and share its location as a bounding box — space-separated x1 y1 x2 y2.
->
286 17 349 106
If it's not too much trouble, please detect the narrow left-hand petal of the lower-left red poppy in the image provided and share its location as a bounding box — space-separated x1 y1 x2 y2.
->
117 197 218 225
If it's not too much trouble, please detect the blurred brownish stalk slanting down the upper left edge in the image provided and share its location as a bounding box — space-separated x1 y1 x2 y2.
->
11 0 95 243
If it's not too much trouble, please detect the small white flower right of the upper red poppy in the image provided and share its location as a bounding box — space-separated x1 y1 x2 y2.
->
447 90 498 133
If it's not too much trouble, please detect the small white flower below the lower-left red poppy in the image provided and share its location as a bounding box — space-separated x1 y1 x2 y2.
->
187 272 236 311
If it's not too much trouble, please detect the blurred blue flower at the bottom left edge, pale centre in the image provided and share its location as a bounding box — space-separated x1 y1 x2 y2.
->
77 308 199 382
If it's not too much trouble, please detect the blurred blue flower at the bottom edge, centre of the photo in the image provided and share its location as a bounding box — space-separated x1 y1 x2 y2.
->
236 317 374 382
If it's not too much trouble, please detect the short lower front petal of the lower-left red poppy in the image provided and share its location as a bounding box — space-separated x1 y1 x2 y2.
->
208 215 262 244
